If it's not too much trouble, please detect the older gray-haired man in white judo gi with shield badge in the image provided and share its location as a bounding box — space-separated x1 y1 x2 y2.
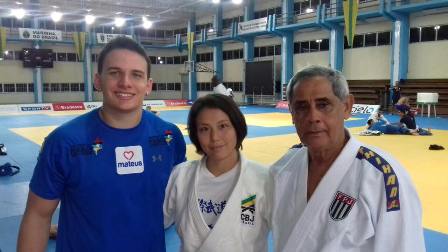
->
270 66 425 252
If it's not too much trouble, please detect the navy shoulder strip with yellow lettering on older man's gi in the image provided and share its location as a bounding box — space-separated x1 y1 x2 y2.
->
356 146 400 212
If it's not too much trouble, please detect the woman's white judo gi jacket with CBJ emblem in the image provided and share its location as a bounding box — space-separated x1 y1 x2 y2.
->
163 154 271 252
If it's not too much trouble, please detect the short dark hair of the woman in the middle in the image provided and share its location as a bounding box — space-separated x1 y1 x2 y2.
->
188 94 247 154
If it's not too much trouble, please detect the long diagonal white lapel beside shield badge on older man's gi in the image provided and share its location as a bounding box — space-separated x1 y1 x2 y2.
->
283 137 360 251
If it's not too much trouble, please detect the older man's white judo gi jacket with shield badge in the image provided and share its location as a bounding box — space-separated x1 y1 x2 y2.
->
270 133 425 252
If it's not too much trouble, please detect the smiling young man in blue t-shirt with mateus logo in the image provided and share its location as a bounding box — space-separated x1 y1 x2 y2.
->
18 37 185 252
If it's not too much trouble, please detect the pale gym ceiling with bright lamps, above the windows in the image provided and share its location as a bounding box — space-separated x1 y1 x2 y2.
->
0 0 269 26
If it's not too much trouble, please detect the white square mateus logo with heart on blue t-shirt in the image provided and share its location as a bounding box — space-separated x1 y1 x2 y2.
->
115 145 144 175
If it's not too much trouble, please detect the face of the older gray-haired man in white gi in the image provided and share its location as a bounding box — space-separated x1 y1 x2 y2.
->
290 77 353 151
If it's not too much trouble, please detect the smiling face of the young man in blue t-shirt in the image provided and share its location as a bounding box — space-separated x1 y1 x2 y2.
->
95 49 152 113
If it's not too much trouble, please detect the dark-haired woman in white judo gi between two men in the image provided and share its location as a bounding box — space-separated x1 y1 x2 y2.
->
164 94 271 252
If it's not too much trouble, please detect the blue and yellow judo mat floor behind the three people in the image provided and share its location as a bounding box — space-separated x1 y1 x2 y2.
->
0 106 448 252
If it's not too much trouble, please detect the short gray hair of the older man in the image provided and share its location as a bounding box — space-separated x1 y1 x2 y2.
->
286 65 349 102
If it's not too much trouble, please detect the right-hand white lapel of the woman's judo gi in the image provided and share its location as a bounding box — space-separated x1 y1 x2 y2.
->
199 155 245 252
